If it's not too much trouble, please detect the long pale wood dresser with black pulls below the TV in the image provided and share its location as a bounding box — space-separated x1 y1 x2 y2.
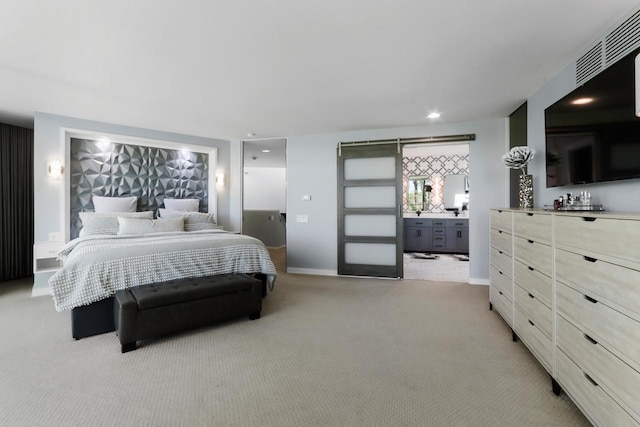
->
489 208 640 426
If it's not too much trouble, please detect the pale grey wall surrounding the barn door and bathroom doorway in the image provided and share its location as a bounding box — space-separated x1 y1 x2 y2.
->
239 119 506 283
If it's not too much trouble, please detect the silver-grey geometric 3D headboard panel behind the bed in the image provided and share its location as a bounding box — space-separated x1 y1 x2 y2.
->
69 138 209 239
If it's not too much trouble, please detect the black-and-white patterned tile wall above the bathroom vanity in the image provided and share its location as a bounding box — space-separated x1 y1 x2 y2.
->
402 154 469 213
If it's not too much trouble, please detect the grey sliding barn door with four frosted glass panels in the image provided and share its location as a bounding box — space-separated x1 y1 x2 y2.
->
338 144 403 278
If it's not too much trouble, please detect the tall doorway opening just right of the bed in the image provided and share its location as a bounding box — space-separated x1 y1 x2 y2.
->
242 138 287 271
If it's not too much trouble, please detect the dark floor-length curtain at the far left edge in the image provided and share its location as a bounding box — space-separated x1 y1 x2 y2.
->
0 123 33 281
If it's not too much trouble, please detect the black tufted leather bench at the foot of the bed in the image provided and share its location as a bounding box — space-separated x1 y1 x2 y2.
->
114 274 263 353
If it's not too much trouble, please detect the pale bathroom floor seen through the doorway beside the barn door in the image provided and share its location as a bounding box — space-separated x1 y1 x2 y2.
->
403 253 469 283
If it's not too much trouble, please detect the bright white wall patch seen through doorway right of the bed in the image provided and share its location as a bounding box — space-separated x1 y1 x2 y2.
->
243 167 287 212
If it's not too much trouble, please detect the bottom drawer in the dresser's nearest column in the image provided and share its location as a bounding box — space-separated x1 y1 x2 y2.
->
556 351 637 427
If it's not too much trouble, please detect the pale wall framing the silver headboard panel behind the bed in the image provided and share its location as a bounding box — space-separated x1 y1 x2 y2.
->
34 113 231 242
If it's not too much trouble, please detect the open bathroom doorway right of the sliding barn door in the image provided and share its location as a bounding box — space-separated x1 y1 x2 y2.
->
402 142 470 283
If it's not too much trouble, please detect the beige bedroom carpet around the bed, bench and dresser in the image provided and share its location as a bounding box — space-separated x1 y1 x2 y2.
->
0 251 588 426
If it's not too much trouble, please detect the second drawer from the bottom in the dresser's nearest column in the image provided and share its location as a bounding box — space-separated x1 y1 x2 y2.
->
556 316 640 420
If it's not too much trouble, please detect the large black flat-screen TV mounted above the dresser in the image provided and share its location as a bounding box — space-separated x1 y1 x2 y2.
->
545 49 640 187
